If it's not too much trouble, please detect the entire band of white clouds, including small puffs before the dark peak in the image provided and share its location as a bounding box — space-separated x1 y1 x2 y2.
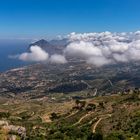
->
10 31 140 66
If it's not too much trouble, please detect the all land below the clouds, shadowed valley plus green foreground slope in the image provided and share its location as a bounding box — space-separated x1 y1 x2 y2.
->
0 56 140 140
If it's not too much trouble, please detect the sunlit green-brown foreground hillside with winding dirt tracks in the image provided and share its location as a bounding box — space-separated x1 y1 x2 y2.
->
0 89 140 140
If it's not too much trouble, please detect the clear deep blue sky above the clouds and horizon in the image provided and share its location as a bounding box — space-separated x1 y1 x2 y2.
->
0 0 140 38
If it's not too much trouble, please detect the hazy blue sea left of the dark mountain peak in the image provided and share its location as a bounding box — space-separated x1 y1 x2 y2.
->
0 39 31 72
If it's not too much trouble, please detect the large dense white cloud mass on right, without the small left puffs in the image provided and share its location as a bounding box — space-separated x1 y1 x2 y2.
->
64 31 140 66
